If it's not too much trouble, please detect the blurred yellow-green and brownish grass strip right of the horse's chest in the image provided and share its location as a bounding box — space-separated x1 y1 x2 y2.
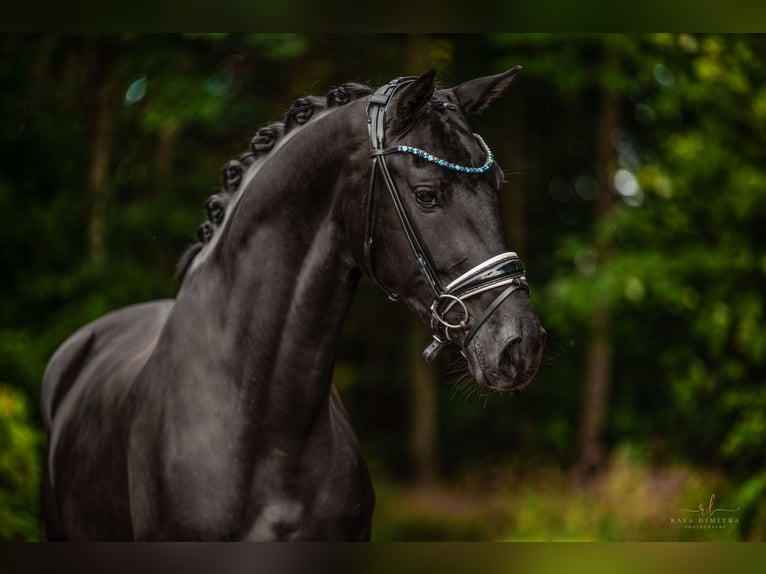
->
373 455 763 542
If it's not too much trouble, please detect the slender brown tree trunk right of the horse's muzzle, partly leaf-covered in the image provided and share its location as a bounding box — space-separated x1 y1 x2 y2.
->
575 88 620 484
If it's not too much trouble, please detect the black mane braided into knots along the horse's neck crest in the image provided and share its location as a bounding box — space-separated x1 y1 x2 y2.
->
176 82 373 281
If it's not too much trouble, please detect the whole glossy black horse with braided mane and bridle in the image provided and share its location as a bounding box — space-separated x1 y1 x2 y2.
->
43 68 545 540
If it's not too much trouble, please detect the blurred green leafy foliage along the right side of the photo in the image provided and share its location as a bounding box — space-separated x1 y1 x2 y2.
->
542 35 766 531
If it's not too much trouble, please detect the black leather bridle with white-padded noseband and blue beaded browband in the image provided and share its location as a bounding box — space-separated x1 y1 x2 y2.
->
364 77 529 361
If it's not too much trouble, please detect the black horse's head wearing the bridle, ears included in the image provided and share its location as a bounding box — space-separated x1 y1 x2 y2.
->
360 67 545 390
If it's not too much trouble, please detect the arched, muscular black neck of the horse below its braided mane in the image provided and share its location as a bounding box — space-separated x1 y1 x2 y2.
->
177 109 363 435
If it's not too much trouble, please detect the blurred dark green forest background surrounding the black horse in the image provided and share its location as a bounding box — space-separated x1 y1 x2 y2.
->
0 34 766 541
